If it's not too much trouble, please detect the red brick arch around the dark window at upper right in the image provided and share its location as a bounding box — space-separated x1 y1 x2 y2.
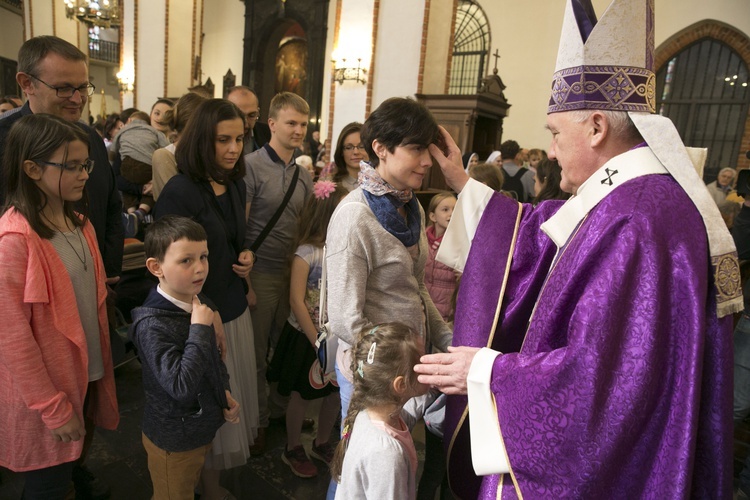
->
654 19 750 167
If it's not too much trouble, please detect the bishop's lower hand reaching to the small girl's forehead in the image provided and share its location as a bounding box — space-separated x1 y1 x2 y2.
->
414 347 479 394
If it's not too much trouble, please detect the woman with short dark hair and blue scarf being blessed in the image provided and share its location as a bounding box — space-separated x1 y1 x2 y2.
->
326 98 452 440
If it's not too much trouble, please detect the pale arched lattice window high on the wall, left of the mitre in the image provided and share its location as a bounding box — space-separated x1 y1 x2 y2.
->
448 0 490 94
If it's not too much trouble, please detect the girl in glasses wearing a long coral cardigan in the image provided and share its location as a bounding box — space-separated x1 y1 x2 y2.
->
0 114 119 499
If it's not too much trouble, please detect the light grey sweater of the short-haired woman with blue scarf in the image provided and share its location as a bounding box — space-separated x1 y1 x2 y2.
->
326 188 453 373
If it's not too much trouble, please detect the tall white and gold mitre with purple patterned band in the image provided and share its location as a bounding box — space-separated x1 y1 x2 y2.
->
547 0 656 113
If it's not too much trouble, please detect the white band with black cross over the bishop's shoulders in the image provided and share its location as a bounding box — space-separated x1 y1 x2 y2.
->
541 147 668 248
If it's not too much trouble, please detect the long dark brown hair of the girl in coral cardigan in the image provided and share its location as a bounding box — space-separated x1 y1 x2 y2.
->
2 113 90 239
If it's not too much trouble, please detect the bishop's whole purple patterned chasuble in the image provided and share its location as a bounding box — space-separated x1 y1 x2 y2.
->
445 171 732 499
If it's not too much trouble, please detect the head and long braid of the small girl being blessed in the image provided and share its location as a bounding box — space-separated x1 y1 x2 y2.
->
331 323 422 482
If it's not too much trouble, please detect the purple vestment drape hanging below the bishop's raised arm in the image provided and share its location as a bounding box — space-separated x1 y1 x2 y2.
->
445 194 563 499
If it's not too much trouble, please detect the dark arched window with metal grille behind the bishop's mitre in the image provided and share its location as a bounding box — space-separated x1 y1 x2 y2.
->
656 38 750 181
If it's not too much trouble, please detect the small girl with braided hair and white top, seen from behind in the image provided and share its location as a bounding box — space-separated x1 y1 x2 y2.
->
331 323 427 500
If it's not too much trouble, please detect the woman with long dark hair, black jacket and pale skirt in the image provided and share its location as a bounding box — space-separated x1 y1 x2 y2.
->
155 99 258 499
